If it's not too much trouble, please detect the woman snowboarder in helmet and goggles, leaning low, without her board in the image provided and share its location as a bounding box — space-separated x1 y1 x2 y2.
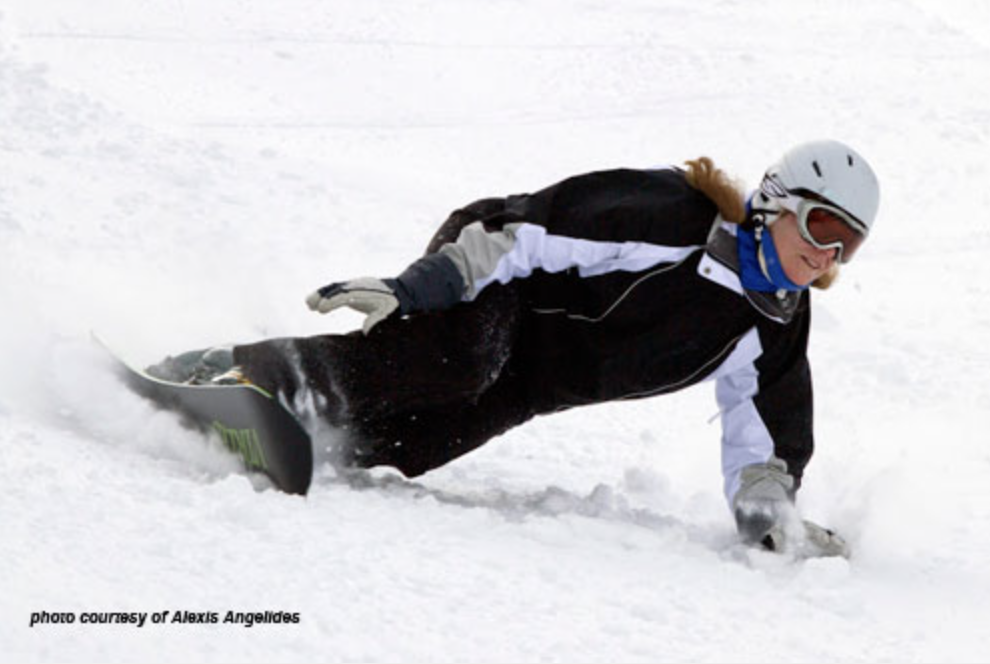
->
153 140 879 555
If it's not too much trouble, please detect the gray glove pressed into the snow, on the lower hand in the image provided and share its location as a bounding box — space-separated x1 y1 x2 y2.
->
732 457 849 557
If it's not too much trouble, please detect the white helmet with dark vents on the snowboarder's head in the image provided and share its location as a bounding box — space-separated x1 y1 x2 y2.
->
760 140 880 235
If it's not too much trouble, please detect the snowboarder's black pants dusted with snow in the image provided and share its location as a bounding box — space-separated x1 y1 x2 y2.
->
234 199 535 477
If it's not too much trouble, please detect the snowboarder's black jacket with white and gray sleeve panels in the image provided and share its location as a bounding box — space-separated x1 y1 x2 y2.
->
391 169 813 502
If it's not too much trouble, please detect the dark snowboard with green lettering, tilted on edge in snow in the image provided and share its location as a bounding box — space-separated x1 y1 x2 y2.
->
93 334 313 495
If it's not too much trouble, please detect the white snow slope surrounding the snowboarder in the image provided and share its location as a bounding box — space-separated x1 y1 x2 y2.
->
0 0 990 662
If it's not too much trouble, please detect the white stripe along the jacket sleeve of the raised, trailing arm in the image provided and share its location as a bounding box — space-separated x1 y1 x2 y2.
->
473 223 700 293
